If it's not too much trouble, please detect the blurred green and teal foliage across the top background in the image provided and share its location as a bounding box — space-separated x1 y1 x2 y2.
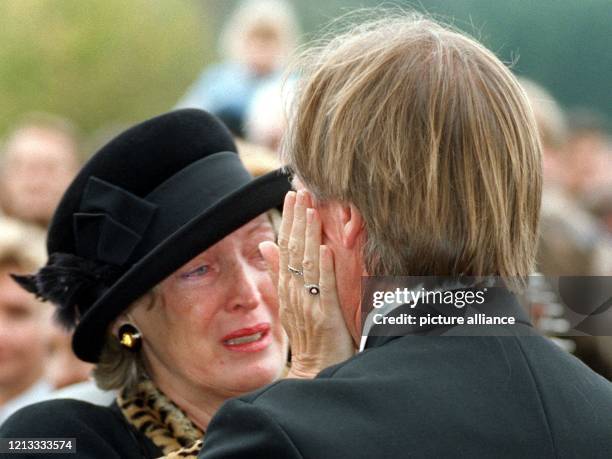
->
0 0 612 145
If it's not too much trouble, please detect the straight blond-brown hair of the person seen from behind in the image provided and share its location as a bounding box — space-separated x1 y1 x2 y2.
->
282 13 541 292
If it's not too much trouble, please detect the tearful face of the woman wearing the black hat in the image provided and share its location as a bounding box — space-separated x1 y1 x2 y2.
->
131 215 287 396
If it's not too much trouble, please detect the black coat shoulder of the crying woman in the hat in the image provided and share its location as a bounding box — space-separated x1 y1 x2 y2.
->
0 400 163 459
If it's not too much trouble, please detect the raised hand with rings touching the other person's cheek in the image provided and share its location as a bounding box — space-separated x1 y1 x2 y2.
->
260 191 355 378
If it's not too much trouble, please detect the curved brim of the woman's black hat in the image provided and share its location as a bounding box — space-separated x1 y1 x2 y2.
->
72 171 291 363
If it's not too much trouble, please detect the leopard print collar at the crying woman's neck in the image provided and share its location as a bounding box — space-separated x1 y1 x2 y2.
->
117 379 204 457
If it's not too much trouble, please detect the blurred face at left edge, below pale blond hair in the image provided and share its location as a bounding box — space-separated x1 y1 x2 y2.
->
0 265 49 404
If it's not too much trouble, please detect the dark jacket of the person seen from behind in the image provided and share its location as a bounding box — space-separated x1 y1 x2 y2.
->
199 295 612 459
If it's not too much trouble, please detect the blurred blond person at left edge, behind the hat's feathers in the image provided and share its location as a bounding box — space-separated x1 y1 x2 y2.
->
0 217 53 424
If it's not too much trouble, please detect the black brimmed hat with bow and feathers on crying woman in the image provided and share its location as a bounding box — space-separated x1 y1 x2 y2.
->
14 109 289 362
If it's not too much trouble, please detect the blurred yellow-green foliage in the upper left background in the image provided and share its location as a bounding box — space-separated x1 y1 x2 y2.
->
0 0 214 138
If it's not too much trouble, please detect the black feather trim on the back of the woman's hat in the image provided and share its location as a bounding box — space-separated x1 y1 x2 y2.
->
11 253 121 328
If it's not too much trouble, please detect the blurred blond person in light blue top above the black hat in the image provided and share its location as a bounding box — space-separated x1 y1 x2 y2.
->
177 0 299 137
